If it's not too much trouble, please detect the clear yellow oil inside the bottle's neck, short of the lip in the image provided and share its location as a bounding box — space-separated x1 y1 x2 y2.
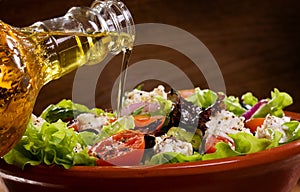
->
37 32 111 83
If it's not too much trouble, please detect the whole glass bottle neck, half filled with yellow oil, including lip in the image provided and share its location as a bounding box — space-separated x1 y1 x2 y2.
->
25 0 135 84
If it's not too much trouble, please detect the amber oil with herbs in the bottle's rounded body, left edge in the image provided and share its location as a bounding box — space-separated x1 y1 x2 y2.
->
0 23 41 156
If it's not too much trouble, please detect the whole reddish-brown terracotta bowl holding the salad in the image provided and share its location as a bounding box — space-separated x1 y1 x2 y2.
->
0 112 300 192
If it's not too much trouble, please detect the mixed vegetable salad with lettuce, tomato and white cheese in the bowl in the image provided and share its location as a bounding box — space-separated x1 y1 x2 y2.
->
4 85 300 169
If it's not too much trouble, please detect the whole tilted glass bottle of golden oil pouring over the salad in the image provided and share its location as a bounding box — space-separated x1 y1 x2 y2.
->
0 0 135 156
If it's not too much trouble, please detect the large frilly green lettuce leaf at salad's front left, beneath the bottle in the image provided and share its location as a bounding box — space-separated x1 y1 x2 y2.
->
4 120 95 169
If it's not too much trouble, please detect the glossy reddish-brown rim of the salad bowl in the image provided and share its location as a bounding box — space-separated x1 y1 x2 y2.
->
0 112 300 178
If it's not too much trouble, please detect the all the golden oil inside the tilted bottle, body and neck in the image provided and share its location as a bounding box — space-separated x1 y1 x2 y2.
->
0 21 134 156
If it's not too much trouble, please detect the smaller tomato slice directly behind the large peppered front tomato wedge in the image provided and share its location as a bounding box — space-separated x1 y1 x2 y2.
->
134 115 166 134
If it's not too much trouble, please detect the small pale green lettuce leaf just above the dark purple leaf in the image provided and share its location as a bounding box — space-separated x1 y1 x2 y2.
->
186 87 218 108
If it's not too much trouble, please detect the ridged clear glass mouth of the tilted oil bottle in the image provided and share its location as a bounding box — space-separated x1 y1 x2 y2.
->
91 0 135 44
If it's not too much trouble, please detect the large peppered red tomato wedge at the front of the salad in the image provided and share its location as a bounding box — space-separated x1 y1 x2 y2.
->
89 130 145 166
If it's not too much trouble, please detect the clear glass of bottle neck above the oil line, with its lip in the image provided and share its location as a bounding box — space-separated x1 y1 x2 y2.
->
31 0 135 55
